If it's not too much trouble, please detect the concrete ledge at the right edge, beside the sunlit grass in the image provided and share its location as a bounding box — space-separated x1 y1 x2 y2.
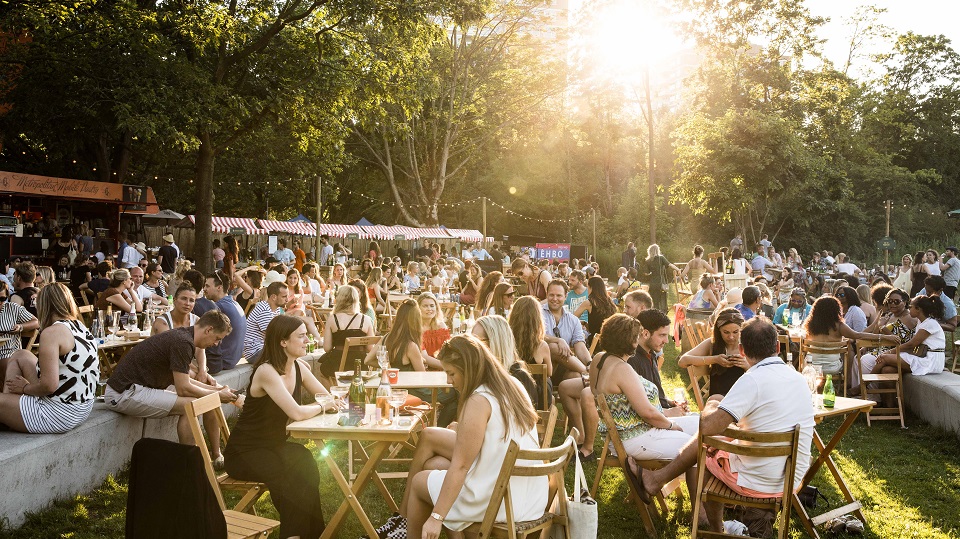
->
903 371 960 438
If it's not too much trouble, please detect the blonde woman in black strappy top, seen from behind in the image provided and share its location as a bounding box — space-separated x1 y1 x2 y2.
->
316 286 373 387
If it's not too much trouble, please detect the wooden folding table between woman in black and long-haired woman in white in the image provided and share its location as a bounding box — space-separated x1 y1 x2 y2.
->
287 412 420 539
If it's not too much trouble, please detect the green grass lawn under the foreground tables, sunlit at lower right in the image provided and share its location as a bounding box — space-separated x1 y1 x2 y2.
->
0 344 960 539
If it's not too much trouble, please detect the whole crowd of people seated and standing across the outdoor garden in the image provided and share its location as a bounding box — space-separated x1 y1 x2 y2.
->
0 228 960 537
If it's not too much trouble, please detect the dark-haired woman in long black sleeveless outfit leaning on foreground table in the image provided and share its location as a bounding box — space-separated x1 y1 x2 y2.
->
223 314 335 539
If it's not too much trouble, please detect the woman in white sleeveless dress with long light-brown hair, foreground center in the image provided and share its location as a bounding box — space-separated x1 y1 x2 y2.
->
378 335 550 537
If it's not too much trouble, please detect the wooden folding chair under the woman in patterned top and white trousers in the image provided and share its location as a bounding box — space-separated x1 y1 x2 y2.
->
590 393 683 539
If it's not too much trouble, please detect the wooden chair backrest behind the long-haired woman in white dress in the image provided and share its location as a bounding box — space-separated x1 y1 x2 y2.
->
468 429 577 539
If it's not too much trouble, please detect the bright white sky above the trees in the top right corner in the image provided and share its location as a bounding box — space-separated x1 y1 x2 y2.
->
807 0 960 70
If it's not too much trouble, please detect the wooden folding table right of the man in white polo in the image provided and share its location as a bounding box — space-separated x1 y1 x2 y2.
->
793 396 876 539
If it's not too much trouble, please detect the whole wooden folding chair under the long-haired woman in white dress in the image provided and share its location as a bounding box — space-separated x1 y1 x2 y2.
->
465 435 580 539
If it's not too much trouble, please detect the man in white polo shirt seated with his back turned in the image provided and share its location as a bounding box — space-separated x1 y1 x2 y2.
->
641 318 814 531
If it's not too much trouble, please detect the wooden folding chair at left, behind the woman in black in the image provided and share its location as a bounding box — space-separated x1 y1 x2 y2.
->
185 393 280 539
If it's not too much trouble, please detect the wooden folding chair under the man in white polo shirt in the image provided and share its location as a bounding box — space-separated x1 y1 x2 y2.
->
692 425 800 539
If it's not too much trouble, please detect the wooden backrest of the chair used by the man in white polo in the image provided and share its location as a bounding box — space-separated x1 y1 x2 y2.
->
698 420 800 505
